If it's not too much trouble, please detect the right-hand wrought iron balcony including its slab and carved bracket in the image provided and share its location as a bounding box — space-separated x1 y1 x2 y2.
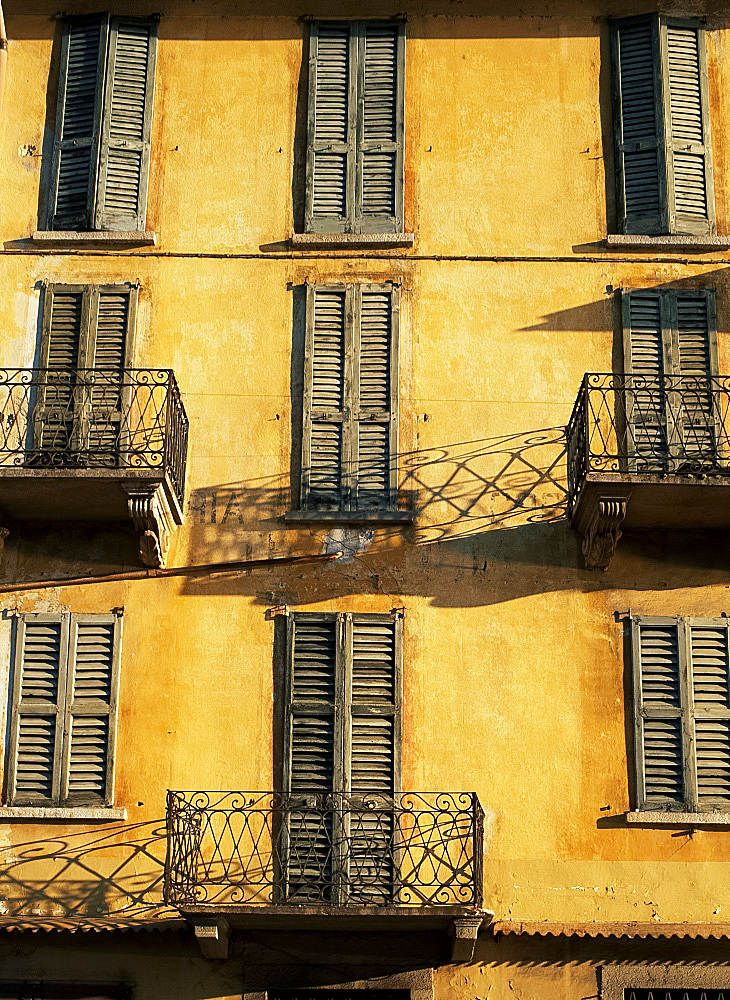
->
567 374 730 569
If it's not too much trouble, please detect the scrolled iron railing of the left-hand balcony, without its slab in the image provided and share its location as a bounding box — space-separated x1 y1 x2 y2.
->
0 368 188 503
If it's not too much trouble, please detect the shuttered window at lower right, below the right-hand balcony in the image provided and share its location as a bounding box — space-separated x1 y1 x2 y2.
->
631 617 730 812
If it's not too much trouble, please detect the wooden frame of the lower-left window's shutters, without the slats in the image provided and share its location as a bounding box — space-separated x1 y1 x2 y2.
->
3 610 123 809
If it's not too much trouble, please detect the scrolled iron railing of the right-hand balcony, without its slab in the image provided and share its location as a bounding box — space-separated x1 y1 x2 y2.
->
567 374 730 511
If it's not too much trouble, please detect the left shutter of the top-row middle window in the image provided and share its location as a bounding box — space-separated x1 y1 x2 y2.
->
305 21 357 233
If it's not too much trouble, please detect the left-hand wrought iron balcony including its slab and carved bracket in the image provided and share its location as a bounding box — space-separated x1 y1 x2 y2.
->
0 368 188 565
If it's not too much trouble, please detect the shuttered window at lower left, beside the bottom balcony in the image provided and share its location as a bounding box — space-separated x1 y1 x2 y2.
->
6 613 122 806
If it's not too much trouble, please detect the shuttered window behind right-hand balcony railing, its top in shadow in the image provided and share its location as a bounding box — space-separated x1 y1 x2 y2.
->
623 289 723 472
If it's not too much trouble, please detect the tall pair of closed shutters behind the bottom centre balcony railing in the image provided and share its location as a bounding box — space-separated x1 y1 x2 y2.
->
284 614 402 903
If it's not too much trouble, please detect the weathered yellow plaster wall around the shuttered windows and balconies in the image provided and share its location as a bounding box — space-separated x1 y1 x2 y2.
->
0 0 730 960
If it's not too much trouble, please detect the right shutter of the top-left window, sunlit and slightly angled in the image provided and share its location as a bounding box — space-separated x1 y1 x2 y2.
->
94 18 157 230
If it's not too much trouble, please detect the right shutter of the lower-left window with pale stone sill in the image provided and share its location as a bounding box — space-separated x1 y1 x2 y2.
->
62 614 122 806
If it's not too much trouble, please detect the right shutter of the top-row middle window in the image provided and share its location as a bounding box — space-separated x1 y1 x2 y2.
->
355 21 405 233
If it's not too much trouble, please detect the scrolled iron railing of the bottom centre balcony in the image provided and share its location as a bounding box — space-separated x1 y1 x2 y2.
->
165 791 484 910
